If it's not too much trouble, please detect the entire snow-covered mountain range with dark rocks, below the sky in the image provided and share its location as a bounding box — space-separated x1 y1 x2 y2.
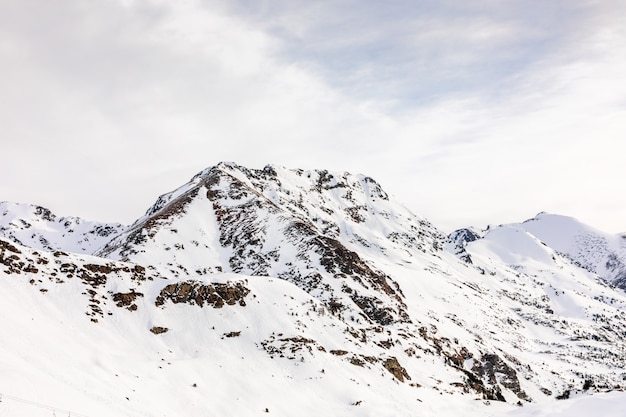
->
0 163 626 416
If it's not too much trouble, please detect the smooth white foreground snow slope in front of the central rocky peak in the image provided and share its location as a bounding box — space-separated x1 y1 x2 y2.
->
0 237 505 416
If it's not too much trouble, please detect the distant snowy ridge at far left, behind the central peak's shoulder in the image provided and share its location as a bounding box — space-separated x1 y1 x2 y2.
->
0 201 124 253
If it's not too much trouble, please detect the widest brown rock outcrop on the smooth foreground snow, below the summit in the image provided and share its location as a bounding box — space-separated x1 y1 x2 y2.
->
155 281 250 308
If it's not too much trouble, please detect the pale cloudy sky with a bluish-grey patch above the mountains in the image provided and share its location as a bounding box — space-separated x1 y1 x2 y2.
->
0 0 626 233
